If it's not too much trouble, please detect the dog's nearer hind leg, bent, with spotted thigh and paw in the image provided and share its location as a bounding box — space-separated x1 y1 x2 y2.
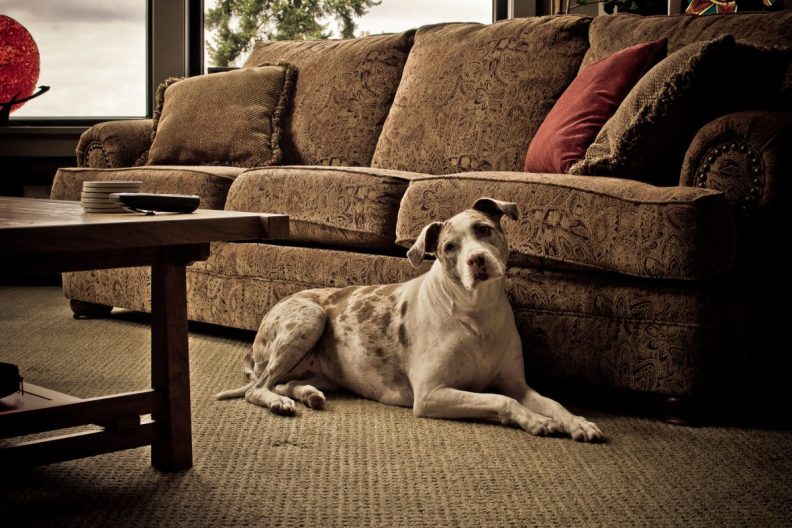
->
245 297 327 415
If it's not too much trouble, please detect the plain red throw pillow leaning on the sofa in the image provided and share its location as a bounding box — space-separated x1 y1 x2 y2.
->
525 37 667 174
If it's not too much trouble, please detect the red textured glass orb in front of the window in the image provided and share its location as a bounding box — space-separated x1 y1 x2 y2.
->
0 15 40 112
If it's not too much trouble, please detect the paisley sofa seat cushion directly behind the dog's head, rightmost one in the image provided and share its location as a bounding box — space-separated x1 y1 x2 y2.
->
396 172 736 280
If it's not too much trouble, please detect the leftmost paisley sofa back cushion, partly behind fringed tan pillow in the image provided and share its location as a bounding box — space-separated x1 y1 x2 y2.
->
244 32 413 166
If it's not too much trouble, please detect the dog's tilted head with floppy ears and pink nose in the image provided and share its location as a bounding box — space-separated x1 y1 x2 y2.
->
407 198 519 290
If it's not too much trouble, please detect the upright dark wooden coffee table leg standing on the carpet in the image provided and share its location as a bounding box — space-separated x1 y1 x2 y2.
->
151 253 192 471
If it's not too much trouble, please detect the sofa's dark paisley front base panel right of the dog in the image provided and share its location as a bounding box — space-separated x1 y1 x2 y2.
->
507 268 740 394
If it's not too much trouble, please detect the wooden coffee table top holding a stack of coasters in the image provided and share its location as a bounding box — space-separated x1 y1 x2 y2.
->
0 197 289 255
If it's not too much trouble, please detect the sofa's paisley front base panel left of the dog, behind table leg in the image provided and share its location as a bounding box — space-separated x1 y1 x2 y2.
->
63 243 431 330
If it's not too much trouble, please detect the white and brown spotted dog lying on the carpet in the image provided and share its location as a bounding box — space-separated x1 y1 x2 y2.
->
217 198 602 441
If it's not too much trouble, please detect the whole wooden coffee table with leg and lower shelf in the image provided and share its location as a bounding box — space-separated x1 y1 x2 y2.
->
0 197 289 471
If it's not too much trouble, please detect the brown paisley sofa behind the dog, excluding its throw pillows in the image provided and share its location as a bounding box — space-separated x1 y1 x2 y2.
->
52 12 792 420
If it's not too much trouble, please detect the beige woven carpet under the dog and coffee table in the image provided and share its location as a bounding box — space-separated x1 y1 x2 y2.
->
0 286 792 527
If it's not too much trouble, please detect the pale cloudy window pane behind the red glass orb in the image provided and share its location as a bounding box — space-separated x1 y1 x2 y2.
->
2 0 148 121
